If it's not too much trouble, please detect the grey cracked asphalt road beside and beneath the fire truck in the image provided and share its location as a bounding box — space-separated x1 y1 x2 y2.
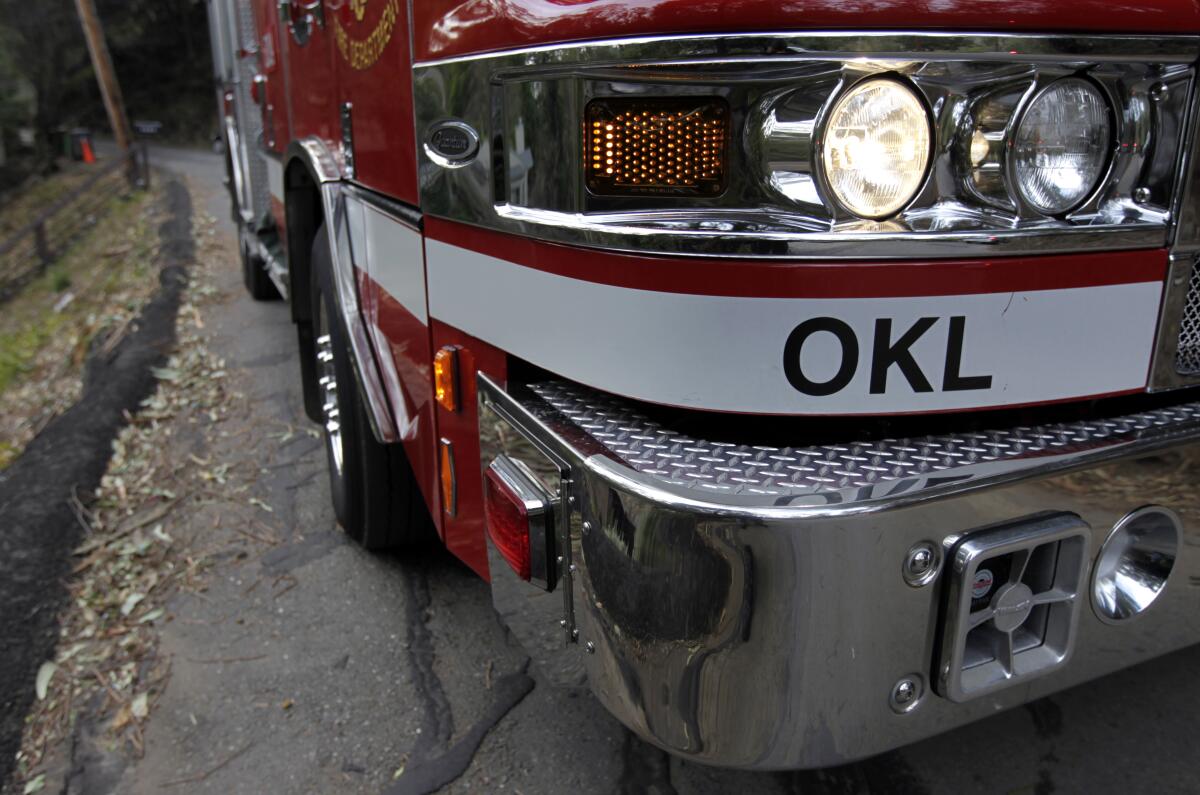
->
95 148 1200 795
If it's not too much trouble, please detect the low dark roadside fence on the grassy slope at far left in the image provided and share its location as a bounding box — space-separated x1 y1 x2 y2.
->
0 143 150 303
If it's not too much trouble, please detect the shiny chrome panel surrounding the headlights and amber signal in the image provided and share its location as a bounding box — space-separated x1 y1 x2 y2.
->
414 32 1200 259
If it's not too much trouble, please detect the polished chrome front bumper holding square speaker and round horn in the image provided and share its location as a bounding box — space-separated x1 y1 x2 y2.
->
479 375 1200 769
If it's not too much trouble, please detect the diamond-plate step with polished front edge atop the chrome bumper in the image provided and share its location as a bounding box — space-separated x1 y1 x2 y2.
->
528 381 1200 507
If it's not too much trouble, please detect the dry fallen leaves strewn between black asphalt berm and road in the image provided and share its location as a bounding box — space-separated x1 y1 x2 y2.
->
12 199 250 791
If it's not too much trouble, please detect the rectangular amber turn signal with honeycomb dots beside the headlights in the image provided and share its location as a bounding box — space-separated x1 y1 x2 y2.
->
583 97 730 197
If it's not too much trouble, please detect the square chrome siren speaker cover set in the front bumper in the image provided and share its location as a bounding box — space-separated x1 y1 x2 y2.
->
936 514 1091 701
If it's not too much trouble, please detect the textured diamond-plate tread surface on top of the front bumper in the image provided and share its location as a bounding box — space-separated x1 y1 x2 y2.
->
528 381 1200 497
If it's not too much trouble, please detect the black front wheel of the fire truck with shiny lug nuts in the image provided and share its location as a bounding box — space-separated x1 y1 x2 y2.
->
312 226 432 549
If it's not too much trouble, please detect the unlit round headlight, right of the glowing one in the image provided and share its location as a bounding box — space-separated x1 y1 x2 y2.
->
1013 77 1112 215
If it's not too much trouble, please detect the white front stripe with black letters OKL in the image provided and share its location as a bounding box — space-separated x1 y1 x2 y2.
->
425 239 1162 414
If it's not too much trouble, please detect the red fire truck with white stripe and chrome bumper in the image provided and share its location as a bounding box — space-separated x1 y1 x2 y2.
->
209 0 1200 769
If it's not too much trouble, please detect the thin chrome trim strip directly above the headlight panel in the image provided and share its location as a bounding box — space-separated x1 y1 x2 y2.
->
413 30 1200 70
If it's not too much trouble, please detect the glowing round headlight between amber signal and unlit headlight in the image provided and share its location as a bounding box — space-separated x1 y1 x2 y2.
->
821 78 932 219
